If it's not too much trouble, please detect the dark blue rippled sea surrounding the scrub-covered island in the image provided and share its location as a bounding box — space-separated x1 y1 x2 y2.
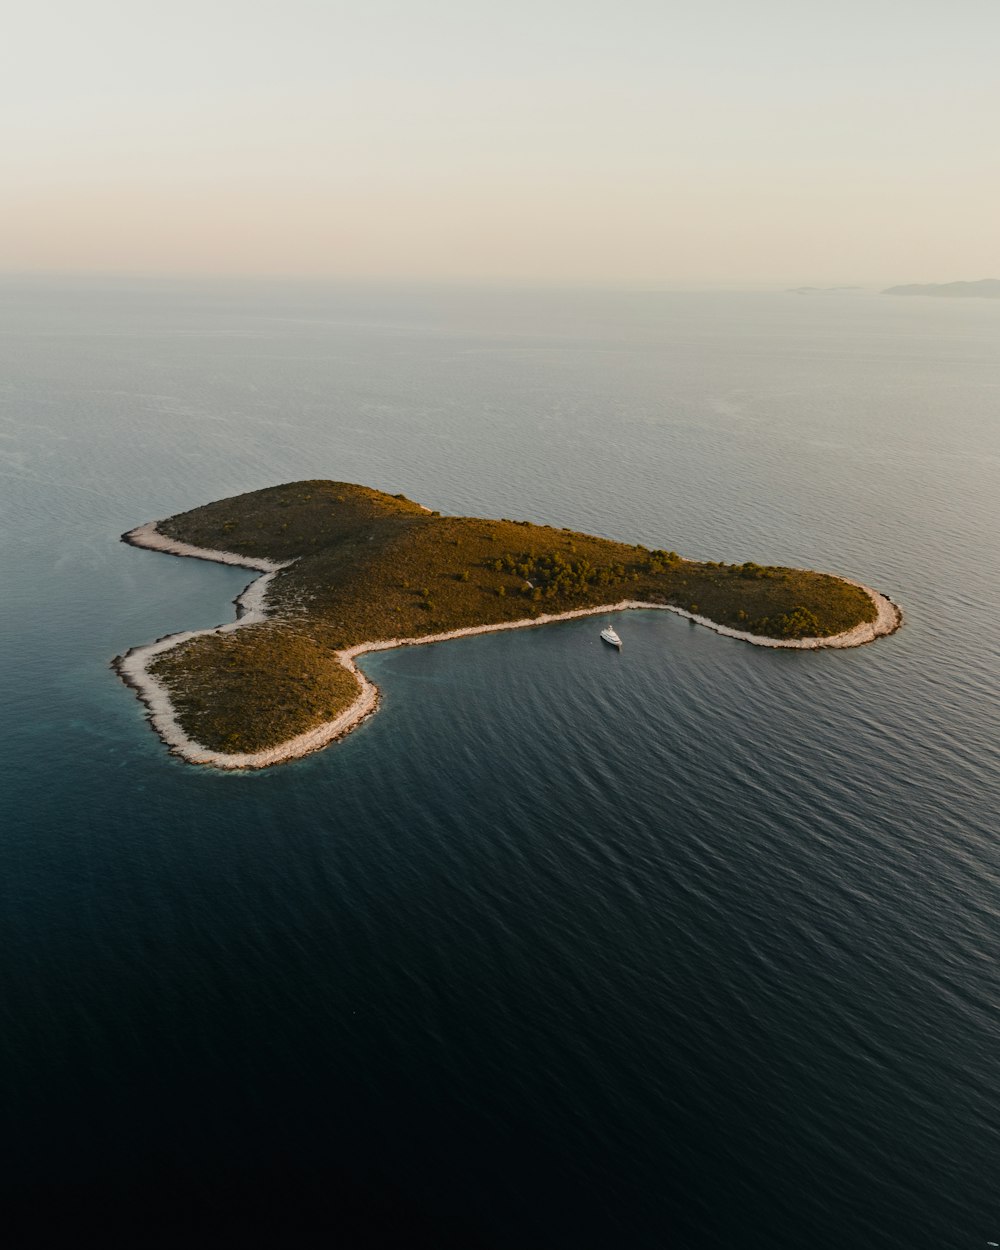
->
0 276 1000 1250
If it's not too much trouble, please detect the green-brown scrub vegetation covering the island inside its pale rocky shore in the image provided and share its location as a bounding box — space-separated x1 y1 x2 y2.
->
151 481 875 753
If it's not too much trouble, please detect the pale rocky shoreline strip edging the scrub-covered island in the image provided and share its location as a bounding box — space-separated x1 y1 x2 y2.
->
111 521 903 770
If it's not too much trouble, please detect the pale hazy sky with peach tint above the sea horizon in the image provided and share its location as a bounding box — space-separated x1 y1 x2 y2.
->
7 0 1000 286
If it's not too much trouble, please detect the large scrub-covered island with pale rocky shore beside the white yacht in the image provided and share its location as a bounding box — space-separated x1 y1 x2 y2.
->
113 481 901 769
